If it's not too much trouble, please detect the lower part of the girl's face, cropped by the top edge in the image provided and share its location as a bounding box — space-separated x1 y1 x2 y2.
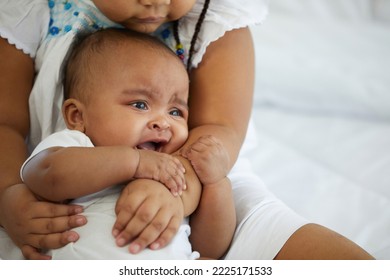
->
93 0 196 33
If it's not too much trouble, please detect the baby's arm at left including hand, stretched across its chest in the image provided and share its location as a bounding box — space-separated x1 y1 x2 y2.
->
23 146 184 201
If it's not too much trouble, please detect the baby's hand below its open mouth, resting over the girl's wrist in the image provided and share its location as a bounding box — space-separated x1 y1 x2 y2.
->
134 150 186 196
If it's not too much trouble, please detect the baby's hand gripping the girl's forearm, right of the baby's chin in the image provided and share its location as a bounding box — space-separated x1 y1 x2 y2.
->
180 135 229 185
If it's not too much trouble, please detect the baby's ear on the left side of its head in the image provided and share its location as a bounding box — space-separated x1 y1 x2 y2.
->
62 98 85 132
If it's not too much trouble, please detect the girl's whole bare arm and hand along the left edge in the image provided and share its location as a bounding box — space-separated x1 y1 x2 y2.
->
0 38 86 259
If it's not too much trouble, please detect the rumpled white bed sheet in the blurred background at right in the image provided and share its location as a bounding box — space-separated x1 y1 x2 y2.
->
252 0 390 259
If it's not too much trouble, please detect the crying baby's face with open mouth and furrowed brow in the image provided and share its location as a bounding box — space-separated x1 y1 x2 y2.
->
83 42 189 153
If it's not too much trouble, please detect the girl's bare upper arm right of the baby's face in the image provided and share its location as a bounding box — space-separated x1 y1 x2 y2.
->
187 28 254 164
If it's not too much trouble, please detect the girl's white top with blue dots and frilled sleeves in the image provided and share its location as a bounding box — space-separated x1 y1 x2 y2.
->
0 0 268 151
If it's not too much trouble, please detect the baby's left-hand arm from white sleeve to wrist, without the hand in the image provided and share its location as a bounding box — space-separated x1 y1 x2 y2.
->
23 146 139 202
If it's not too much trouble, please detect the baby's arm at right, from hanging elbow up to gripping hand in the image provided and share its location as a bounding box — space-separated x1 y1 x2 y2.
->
181 136 236 259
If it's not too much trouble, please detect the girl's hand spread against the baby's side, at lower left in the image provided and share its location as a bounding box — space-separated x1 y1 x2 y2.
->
0 184 87 260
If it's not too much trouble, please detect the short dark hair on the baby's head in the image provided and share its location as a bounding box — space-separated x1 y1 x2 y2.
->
62 28 182 100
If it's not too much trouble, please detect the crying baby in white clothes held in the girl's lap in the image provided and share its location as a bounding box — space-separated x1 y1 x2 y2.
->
21 29 229 259
